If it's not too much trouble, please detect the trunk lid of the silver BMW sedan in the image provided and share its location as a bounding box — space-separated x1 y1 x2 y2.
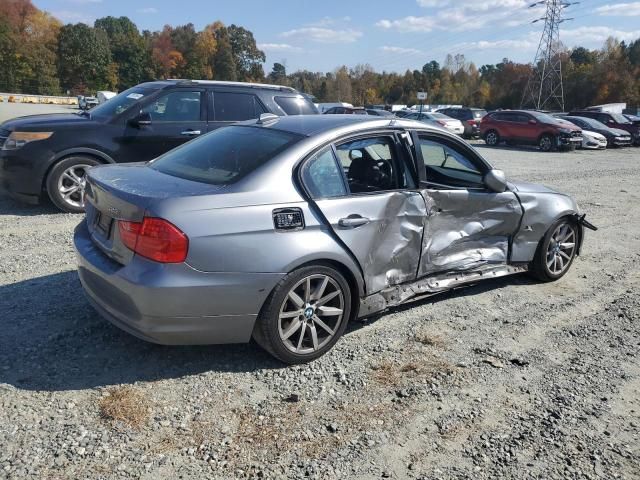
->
85 164 221 265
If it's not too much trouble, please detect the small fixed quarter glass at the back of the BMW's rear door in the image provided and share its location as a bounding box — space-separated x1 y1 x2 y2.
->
302 148 347 198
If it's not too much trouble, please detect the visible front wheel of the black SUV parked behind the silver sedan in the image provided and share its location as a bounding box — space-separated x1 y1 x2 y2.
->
45 155 100 213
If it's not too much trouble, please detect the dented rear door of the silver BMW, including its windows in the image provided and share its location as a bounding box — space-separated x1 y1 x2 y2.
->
302 133 426 294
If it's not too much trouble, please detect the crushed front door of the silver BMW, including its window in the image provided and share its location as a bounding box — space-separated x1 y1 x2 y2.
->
412 132 522 277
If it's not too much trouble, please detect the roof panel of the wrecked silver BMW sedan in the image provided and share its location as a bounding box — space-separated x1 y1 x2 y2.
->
240 114 442 136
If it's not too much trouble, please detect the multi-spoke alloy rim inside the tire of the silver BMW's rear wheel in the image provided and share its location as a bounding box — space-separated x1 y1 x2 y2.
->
278 274 345 355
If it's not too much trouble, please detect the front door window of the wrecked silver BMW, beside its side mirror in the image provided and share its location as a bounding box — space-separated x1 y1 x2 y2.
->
418 137 483 187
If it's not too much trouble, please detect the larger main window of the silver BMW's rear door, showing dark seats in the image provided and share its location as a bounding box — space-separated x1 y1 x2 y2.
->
336 137 414 193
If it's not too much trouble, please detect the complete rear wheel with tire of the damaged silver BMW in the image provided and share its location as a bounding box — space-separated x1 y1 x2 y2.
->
253 265 351 364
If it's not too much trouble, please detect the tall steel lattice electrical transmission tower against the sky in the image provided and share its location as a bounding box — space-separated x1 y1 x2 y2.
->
521 0 578 111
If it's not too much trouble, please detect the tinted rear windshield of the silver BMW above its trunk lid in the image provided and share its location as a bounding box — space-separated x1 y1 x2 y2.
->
149 126 302 185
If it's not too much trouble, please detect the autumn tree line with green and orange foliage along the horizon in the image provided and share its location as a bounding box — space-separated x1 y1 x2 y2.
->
0 0 640 109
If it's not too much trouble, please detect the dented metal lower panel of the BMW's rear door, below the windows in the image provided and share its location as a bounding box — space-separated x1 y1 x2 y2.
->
317 191 426 294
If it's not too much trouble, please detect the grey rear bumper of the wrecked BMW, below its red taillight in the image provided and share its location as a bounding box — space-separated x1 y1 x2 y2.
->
74 221 284 345
